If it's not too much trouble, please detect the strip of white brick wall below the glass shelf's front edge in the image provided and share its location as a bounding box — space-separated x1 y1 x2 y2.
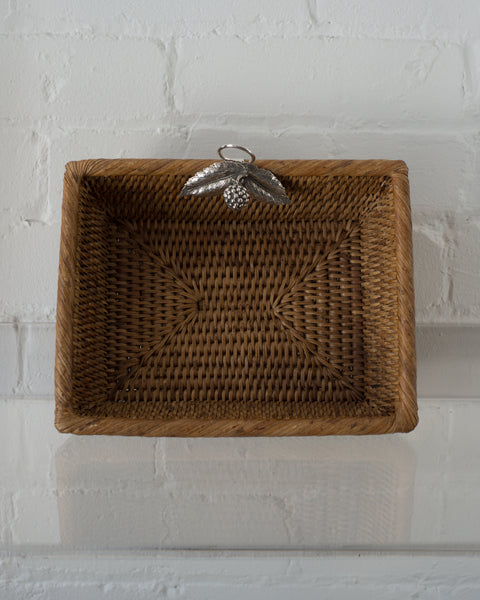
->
0 553 480 600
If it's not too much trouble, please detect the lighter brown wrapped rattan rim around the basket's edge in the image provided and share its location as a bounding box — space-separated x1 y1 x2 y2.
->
55 159 418 437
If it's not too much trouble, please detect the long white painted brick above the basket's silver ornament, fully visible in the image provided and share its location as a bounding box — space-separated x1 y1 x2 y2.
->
174 36 463 122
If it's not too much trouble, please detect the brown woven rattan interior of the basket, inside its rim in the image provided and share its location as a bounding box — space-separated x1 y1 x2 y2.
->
73 171 399 419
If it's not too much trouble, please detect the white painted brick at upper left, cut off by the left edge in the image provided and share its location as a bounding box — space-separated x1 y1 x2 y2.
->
0 35 167 127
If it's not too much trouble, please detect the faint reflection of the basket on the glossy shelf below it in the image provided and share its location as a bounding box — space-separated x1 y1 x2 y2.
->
56 436 416 549
